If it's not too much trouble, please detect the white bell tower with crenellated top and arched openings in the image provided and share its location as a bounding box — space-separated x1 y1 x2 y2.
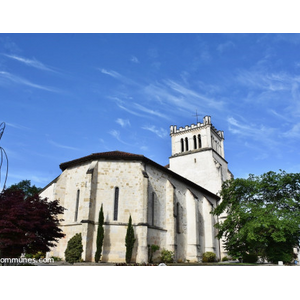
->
169 116 232 194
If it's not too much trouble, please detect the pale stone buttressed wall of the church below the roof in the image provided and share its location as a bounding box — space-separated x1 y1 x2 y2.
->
41 160 218 263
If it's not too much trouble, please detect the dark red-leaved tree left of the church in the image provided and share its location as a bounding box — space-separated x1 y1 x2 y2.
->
0 189 64 257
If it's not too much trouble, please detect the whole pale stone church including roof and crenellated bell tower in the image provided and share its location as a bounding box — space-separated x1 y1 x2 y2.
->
40 116 232 263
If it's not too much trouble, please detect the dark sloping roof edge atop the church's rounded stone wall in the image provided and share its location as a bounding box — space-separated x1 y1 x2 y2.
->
59 151 220 200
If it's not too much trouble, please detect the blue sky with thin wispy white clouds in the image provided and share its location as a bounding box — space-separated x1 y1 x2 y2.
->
0 33 300 187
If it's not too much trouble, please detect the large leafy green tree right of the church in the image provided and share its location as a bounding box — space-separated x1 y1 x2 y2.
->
213 171 300 262
